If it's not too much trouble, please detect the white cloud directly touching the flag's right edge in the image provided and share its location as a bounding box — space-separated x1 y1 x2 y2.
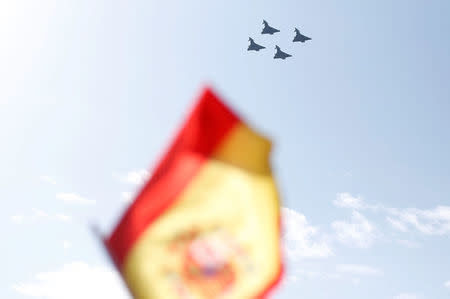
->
282 208 333 260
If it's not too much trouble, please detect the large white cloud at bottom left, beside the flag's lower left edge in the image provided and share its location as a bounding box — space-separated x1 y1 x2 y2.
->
13 262 131 299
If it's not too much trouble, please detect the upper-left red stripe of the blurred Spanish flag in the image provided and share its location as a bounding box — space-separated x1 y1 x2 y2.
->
105 88 239 269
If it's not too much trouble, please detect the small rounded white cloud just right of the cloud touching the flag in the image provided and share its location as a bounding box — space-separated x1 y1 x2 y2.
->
331 211 377 248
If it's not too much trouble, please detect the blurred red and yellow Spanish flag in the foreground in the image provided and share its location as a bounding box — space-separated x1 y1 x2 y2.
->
104 89 282 299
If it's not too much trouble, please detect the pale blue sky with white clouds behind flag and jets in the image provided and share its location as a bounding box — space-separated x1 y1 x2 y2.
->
0 0 450 299
